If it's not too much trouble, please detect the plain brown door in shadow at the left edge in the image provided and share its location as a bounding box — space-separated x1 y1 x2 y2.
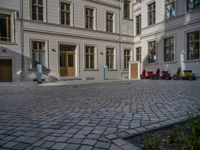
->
0 59 12 82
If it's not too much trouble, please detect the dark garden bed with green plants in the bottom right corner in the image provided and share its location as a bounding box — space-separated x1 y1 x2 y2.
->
127 116 200 150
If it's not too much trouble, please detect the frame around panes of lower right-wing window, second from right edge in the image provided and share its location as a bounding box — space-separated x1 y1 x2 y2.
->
163 36 176 63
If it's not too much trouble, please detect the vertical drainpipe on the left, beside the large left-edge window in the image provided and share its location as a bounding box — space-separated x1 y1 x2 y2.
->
20 0 24 81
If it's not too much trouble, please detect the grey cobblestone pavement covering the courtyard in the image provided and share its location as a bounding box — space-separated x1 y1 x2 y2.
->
0 80 200 150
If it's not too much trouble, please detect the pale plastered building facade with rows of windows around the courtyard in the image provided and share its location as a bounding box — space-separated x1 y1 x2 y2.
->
0 0 200 81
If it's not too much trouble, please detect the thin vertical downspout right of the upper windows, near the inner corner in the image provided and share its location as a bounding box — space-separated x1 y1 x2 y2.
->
119 0 122 78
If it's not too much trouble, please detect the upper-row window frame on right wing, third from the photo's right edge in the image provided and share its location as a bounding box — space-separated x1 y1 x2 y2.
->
147 1 156 26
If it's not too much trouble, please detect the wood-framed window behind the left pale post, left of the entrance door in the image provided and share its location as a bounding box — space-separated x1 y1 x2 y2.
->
32 41 45 68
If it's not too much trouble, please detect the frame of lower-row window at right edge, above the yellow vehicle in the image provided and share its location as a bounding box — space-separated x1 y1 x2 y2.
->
185 30 200 61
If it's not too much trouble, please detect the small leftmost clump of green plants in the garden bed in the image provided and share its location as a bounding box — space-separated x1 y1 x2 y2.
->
145 134 161 150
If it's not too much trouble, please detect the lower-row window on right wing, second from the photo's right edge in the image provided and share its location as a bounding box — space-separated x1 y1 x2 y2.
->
164 37 174 62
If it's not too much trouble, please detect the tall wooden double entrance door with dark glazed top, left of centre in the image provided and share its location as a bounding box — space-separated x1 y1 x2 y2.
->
60 45 76 77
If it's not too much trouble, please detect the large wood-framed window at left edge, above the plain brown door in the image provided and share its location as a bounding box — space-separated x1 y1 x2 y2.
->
0 13 11 42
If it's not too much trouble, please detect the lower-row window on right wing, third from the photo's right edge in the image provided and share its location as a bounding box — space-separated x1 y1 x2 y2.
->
148 41 156 63
